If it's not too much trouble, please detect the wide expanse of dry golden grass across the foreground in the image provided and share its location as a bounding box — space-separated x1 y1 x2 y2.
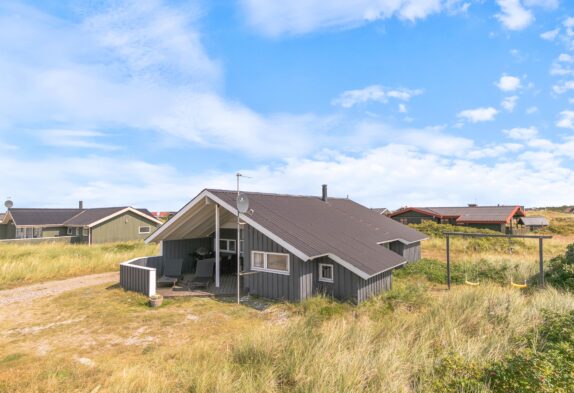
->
0 284 574 392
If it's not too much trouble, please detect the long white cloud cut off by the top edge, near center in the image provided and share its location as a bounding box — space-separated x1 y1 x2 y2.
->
240 0 468 36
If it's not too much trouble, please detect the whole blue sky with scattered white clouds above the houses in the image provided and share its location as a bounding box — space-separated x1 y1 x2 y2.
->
0 0 574 211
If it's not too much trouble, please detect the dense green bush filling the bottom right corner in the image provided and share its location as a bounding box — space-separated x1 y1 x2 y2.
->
426 311 574 393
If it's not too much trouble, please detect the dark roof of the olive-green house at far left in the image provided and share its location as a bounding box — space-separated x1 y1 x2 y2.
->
8 206 155 226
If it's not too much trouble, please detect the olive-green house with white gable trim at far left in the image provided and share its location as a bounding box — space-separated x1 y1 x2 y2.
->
0 207 161 244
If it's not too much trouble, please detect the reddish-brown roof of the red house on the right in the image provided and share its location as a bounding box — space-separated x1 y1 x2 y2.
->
392 205 524 224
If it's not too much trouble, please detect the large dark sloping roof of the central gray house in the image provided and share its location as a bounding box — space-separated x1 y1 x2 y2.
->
209 190 426 276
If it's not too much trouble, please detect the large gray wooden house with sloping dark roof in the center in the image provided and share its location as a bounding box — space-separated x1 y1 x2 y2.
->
140 187 426 302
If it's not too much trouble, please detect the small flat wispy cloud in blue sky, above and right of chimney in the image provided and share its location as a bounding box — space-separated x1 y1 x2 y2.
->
332 85 423 108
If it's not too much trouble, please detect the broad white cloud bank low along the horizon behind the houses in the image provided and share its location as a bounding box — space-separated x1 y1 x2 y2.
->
0 141 574 210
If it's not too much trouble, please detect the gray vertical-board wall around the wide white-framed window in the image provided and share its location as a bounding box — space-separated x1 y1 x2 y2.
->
243 225 309 301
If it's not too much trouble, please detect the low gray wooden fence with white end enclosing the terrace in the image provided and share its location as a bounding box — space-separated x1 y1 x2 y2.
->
120 257 162 296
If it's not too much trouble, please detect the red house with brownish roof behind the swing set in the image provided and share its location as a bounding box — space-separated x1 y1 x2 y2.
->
390 205 525 233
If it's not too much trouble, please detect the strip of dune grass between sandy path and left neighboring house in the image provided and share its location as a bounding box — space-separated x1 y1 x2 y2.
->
0 241 159 289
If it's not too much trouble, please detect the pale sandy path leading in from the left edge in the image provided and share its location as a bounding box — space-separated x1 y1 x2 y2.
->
0 272 120 306
